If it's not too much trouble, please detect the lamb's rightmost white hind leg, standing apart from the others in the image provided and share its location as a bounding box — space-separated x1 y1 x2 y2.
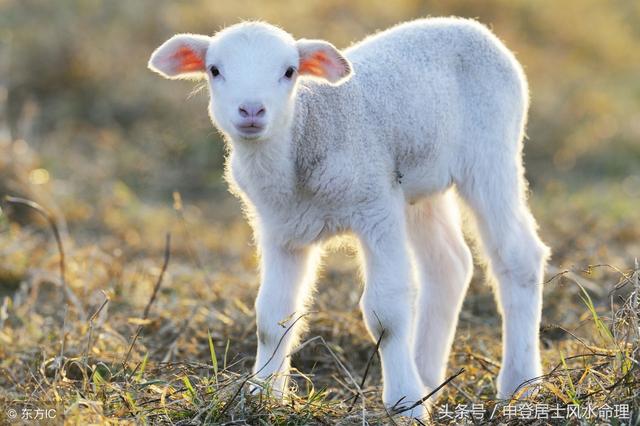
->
461 163 548 398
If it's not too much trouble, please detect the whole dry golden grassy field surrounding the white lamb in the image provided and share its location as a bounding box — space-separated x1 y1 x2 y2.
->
0 0 640 424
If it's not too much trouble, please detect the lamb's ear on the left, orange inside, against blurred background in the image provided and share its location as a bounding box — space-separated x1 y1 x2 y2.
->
149 34 211 79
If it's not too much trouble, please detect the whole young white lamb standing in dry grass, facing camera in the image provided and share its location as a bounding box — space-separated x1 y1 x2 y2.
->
149 18 548 417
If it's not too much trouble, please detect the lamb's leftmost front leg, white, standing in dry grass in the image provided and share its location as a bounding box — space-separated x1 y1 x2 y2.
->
253 242 319 396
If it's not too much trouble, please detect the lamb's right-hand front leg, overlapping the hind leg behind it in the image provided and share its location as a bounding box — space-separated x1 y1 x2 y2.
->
360 203 425 417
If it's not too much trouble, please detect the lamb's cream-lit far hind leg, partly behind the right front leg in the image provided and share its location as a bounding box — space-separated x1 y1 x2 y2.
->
407 190 473 389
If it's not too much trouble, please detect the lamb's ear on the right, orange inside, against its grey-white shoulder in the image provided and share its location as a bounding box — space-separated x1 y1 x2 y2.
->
296 39 351 84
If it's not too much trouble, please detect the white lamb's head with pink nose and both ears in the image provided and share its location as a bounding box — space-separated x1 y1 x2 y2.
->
149 22 351 141
